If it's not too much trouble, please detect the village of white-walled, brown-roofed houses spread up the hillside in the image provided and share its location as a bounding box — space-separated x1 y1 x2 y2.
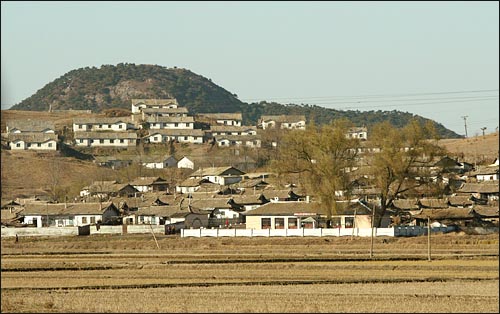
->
1 98 499 235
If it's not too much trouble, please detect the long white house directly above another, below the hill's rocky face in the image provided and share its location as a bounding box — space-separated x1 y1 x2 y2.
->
73 117 134 133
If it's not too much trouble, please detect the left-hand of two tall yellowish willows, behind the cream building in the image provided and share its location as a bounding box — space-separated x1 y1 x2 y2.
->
273 119 359 219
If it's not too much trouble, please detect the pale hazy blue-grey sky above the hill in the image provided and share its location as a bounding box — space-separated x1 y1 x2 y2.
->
1 1 499 136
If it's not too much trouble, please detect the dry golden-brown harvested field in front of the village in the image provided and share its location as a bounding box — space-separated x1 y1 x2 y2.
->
1 234 499 313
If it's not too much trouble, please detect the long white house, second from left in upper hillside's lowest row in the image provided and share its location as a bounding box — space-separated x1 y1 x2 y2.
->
74 132 137 148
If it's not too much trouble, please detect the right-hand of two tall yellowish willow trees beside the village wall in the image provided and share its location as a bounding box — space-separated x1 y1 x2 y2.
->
363 120 445 226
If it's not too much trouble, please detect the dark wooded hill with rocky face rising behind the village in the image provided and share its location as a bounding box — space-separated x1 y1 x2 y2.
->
11 63 461 138
